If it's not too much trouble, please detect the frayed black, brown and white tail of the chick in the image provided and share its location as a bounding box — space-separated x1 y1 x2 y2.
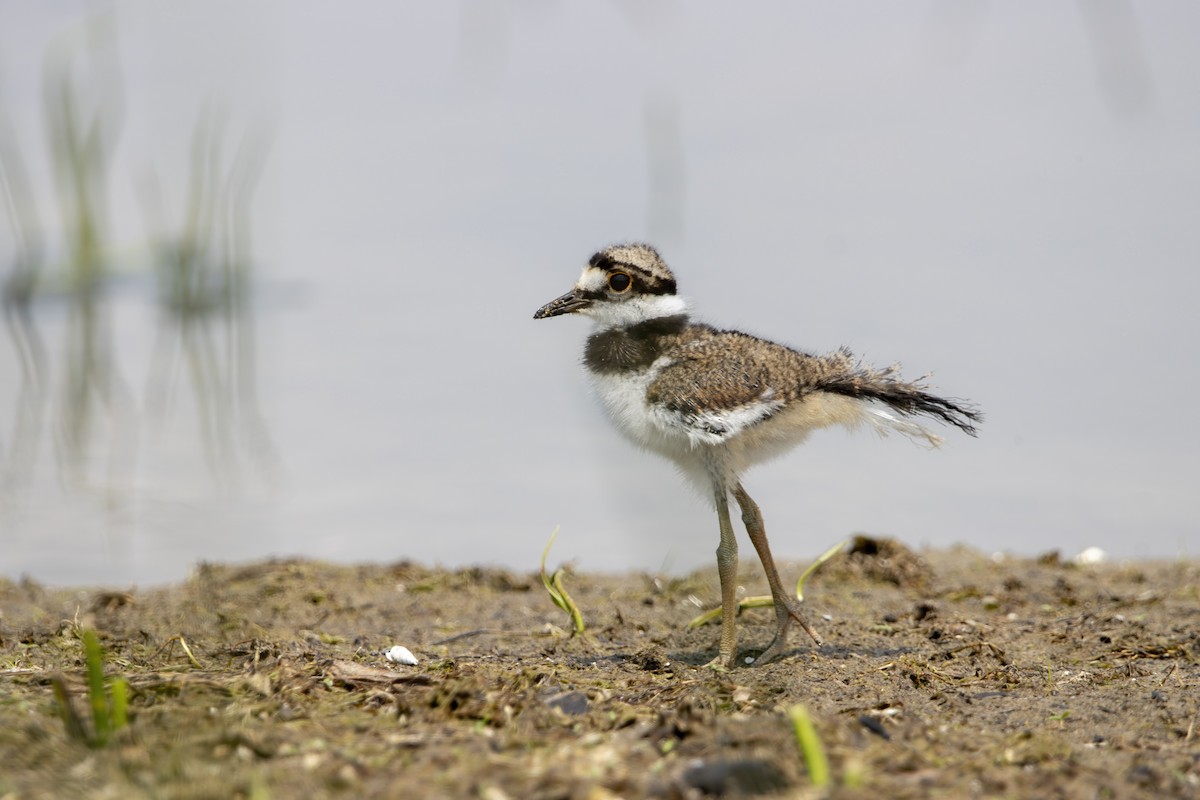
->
816 348 983 447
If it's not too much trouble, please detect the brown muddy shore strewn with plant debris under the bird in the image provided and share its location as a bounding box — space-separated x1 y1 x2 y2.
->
0 541 1200 800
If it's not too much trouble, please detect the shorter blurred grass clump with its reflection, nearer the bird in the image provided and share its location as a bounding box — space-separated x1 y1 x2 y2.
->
144 110 275 489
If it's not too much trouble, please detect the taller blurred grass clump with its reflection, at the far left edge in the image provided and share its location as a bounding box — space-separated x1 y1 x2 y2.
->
0 7 133 513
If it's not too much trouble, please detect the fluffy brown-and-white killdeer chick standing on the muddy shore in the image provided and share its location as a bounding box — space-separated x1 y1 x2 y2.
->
534 245 980 668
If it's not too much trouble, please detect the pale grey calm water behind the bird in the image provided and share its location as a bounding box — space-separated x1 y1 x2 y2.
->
0 1 1200 584
